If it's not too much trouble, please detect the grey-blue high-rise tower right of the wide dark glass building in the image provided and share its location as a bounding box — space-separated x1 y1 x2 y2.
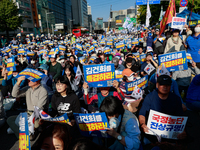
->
72 0 88 27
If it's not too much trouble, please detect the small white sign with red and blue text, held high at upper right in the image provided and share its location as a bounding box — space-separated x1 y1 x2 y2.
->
171 17 186 30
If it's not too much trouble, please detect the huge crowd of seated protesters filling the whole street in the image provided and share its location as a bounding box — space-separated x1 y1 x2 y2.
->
0 24 200 150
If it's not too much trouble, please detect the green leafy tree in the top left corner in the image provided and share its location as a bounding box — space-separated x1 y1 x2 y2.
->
0 0 23 40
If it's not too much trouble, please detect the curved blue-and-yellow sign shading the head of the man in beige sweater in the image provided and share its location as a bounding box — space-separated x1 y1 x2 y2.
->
16 68 46 82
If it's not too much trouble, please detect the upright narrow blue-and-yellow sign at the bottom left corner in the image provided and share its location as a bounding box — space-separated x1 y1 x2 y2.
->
19 113 31 150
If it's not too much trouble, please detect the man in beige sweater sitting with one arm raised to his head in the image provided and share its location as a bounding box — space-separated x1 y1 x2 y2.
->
7 76 49 140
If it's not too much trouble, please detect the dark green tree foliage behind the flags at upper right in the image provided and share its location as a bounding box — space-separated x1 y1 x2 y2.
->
137 0 200 25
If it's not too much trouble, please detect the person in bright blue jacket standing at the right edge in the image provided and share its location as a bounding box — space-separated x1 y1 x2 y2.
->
185 24 200 69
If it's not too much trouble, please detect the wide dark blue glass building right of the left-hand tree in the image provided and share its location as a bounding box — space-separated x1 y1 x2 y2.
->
36 0 72 33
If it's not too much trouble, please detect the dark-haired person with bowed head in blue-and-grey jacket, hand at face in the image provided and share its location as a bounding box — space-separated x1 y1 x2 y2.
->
100 96 140 150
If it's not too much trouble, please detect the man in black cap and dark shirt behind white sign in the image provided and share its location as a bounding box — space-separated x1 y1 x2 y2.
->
139 75 183 142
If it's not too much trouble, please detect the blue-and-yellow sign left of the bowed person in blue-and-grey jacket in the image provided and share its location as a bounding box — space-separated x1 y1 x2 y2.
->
74 112 110 138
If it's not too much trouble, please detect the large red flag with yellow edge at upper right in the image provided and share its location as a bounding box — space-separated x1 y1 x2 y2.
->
160 0 176 35
